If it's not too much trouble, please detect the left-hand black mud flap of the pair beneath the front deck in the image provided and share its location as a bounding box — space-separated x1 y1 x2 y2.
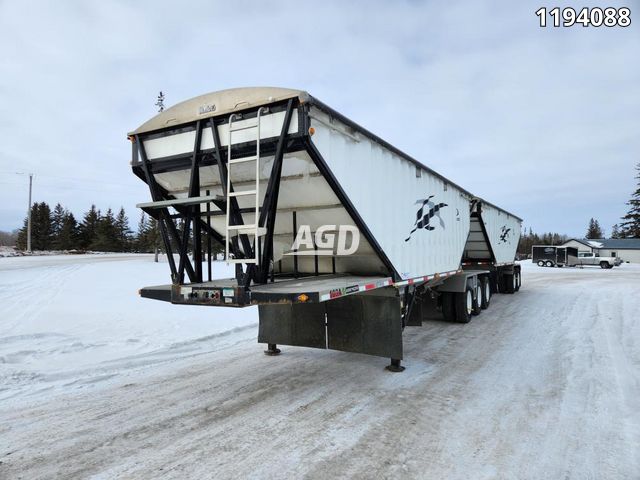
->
258 303 327 348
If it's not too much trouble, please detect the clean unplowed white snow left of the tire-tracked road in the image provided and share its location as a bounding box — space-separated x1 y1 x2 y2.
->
0 254 257 405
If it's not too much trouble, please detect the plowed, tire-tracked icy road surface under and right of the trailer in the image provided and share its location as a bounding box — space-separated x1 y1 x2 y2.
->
0 265 640 480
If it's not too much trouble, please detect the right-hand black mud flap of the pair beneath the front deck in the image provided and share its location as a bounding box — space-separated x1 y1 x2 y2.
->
326 295 402 359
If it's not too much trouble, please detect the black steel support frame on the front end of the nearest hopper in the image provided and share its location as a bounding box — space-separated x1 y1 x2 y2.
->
132 98 400 289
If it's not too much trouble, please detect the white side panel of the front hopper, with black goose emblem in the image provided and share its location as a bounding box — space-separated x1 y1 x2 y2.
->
310 104 470 279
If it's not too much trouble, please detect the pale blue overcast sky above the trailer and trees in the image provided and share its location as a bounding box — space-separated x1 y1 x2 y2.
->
0 0 640 236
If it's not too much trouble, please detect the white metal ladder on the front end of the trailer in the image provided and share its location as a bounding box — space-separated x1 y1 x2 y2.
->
225 107 267 265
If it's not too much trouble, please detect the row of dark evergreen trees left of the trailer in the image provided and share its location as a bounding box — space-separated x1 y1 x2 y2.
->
16 202 160 252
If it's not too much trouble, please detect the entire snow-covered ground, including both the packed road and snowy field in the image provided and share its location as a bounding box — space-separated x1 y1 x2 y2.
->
0 256 640 479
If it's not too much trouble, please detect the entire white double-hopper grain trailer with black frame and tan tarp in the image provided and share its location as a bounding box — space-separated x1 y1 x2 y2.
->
129 88 521 370
